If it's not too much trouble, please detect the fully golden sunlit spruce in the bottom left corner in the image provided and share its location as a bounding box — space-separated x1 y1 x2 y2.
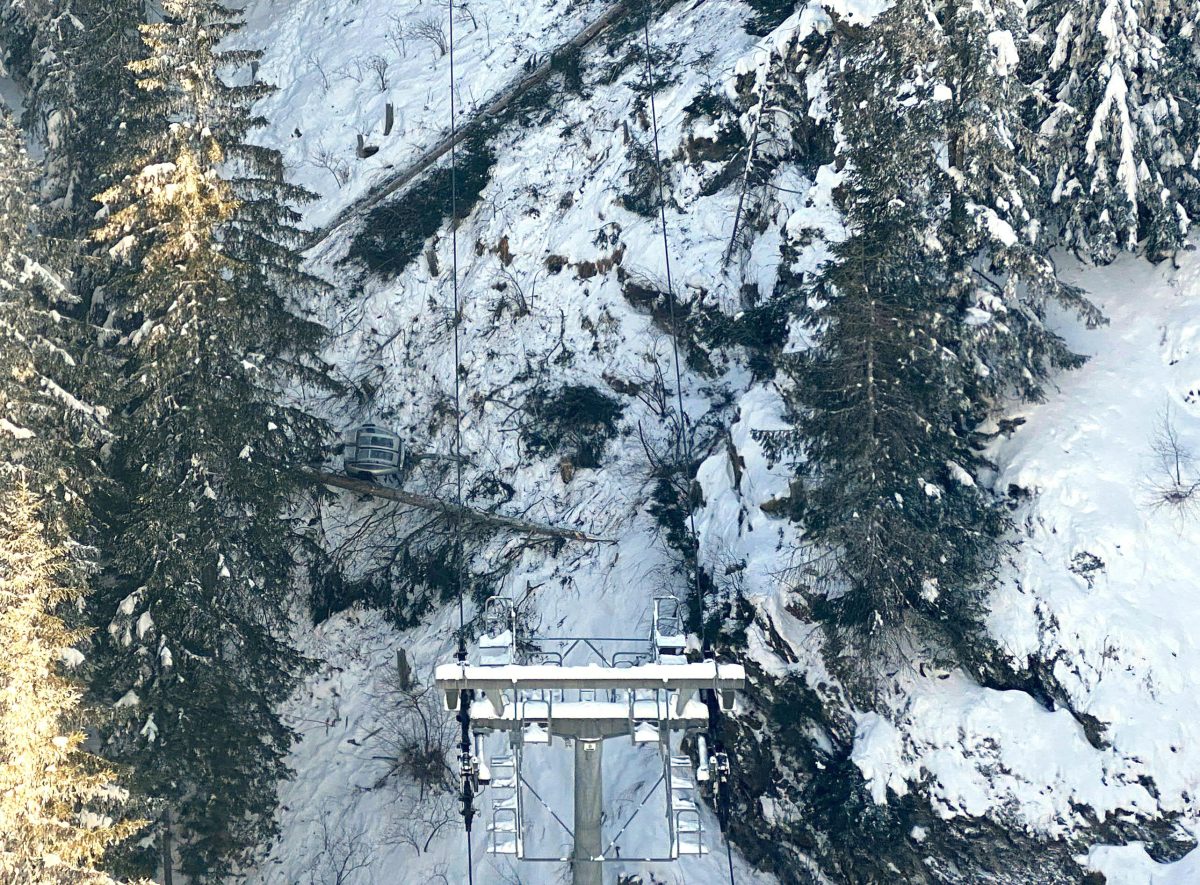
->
0 482 142 885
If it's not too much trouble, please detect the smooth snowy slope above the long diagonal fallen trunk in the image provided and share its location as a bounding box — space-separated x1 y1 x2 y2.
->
239 0 619 227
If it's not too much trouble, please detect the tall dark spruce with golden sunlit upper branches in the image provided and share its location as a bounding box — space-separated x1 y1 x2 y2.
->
90 0 325 880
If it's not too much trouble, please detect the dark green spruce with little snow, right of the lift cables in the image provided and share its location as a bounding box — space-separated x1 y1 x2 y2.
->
768 32 1002 675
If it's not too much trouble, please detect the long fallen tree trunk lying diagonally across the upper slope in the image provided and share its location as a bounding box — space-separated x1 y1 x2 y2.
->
304 0 631 249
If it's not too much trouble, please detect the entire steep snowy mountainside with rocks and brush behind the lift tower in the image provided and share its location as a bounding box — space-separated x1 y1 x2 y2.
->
231 0 1200 885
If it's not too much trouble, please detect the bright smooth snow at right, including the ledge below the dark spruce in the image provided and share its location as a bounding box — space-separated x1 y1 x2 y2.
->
856 253 1200 883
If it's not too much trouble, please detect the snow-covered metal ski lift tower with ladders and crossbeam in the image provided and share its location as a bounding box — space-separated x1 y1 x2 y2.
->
434 596 745 885
